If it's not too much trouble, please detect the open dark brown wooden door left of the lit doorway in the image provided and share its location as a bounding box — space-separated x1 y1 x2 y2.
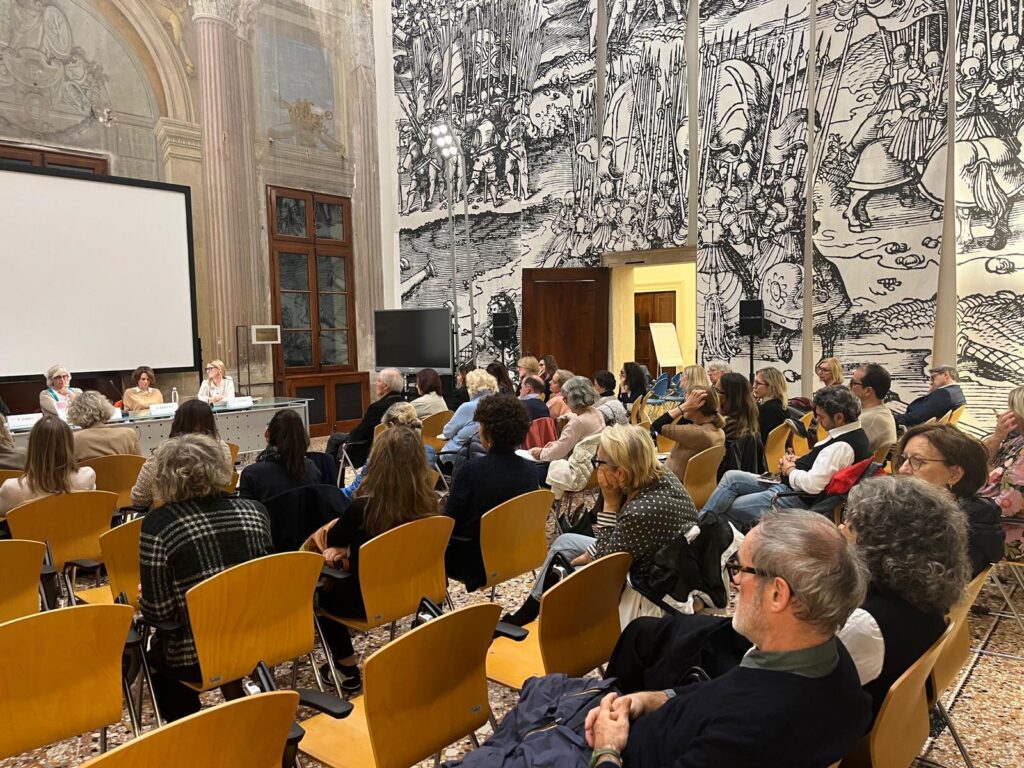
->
521 268 610 378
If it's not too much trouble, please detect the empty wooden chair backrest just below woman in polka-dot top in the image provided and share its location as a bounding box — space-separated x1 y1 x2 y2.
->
538 552 633 677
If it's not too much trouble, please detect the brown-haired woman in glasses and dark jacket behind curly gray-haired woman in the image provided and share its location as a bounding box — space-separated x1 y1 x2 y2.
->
895 424 1006 577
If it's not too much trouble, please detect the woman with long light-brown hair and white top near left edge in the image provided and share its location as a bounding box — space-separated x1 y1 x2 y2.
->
0 415 96 517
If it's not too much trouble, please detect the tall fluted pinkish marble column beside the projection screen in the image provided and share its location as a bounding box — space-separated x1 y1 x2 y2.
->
193 0 266 370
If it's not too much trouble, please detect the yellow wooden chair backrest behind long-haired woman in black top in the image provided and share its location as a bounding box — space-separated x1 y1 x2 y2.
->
359 515 455 627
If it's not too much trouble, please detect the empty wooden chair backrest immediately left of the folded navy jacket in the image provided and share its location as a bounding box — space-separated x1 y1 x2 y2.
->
362 603 501 768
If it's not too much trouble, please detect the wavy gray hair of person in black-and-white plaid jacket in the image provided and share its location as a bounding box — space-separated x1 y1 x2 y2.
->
153 432 232 504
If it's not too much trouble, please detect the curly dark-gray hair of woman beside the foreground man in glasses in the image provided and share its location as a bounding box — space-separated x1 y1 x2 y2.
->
846 476 971 615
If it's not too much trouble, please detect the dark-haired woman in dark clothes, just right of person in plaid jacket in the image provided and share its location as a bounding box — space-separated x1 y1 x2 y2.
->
239 411 321 502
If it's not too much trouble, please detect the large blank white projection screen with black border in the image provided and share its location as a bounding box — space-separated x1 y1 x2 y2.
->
0 170 200 378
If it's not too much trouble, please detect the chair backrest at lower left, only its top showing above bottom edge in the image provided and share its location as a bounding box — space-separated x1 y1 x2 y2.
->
83 690 299 768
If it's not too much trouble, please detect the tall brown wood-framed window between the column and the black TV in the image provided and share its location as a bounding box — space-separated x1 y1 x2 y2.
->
267 186 356 376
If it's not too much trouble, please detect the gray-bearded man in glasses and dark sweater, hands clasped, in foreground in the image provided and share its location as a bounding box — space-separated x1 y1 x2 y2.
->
586 510 871 768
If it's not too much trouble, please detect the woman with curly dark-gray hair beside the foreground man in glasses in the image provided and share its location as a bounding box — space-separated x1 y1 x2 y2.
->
839 477 970 715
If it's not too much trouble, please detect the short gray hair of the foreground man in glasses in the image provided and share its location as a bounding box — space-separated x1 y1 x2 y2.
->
751 509 869 633
